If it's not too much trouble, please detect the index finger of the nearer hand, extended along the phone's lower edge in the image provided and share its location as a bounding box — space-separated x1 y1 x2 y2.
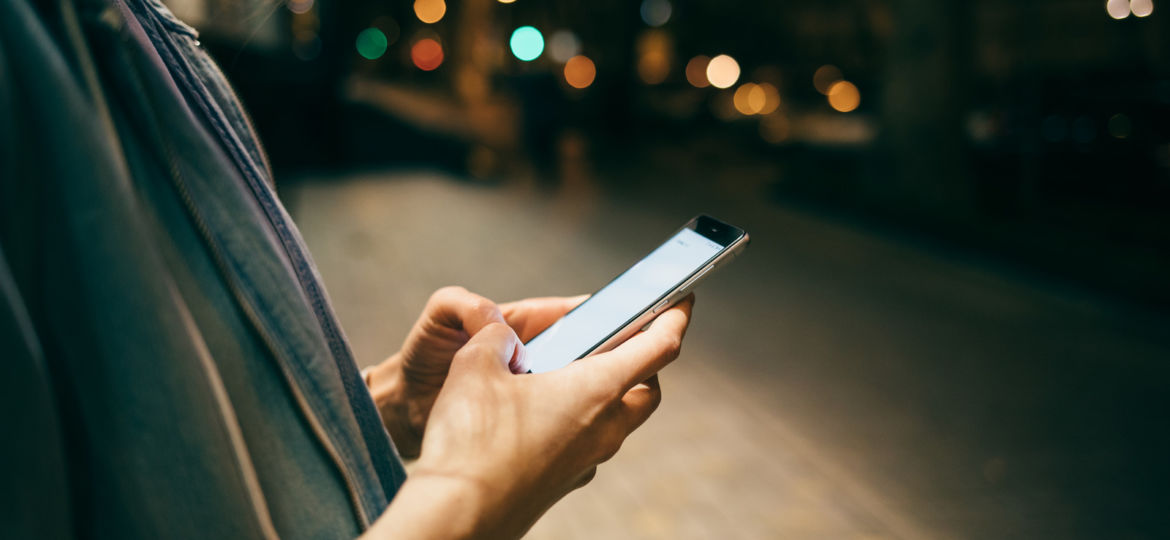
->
576 295 695 393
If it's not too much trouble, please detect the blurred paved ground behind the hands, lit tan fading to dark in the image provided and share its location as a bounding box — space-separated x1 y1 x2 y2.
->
282 171 1170 540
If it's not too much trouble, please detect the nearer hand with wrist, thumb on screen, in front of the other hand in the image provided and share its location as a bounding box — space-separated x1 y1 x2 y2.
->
371 297 693 538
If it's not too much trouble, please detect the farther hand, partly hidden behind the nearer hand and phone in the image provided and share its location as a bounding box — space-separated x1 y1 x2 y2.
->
366 286 585 457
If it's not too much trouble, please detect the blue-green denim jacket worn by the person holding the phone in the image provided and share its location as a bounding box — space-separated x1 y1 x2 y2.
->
0 0 406 538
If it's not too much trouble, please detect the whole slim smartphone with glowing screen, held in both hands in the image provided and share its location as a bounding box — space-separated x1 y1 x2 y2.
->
524 215 750 373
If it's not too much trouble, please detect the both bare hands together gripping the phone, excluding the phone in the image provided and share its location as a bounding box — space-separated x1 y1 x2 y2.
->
366 288 694 539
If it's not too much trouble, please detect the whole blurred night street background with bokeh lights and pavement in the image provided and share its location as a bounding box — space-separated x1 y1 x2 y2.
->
167 0 1170 539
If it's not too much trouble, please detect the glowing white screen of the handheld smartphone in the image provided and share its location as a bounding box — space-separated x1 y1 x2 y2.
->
524 229 723 373
